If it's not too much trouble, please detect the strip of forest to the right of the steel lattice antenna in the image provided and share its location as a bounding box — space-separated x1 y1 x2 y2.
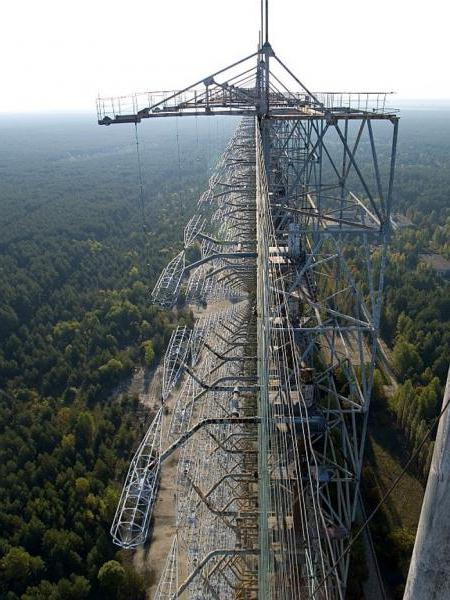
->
363 110 450 599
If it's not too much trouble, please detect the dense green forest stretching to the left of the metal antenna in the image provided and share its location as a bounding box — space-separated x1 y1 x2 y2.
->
0 115 237 600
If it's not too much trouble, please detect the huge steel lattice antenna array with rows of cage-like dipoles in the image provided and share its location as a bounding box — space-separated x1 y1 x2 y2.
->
98 2 398 600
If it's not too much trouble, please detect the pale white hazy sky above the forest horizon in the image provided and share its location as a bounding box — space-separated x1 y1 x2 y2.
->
0 0 450 112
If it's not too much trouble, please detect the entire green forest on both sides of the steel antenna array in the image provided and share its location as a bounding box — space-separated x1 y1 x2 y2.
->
0 109 450 600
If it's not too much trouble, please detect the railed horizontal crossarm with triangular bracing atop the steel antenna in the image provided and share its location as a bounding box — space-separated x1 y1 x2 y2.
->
97 46 396 125
